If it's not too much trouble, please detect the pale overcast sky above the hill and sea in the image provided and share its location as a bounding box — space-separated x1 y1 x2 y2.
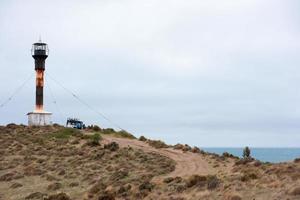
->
0 0 300 147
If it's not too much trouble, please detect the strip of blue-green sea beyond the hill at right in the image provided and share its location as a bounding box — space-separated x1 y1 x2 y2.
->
201 147 300 163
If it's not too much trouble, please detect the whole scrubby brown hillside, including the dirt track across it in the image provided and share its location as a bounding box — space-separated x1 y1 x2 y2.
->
0 124 300 200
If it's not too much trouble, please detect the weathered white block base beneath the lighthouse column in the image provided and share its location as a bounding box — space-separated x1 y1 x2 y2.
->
27 111 52 126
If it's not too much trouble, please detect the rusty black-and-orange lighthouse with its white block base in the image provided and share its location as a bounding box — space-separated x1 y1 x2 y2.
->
27 39 52 126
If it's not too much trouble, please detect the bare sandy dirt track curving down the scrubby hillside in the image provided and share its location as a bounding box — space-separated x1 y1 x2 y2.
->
104 136 215 178
